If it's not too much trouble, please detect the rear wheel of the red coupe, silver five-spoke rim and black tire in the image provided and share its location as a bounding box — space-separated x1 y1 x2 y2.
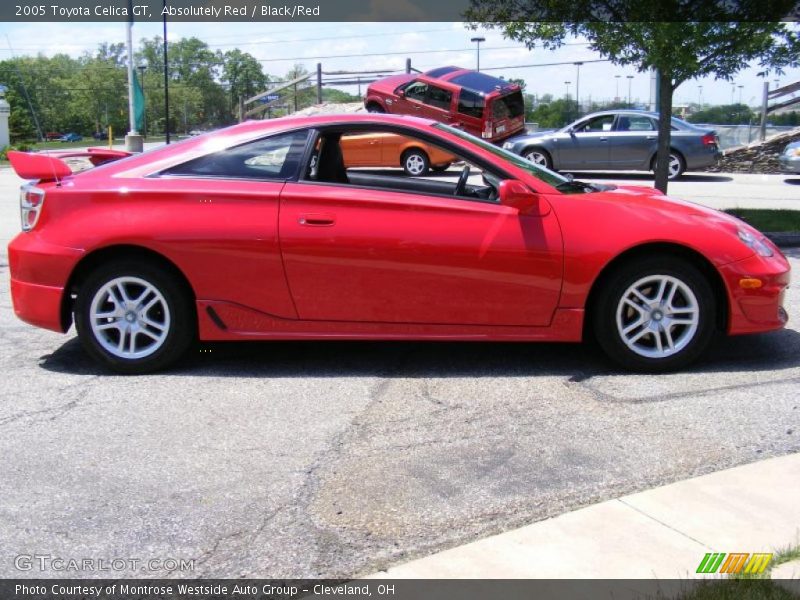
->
75 260 197 374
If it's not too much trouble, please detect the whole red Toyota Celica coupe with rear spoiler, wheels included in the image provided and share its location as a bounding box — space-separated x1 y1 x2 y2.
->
9 114 789 373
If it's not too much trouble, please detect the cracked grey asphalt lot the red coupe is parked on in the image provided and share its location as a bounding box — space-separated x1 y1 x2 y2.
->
0 169 800 578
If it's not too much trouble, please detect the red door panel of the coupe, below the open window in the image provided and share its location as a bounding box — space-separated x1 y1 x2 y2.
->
279 132 562 326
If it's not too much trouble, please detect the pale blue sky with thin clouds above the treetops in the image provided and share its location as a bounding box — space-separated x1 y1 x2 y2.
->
0 23 800 106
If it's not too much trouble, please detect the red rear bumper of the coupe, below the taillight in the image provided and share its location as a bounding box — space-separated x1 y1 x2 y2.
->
8 232 83 333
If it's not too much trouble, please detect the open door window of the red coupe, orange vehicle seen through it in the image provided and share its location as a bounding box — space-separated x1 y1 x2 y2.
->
303 127 501 202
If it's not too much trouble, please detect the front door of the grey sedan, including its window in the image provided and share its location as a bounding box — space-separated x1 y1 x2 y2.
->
555 115 614 169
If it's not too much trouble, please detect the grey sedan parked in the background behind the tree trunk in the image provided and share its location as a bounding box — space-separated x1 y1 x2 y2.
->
503 110 722 179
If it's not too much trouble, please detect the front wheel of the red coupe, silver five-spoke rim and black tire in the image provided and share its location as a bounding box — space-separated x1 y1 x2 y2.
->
589 255 717 373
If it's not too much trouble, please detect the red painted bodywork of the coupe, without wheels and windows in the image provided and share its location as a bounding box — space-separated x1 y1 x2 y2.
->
4 115 789 341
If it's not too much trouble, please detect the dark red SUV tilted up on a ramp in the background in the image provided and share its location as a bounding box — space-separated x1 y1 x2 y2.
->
364 67 525 143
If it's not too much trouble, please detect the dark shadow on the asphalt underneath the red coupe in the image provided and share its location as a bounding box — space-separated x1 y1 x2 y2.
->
39 329 800 381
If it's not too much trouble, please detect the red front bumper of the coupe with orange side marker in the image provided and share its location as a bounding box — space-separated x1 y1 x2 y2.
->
719 243 791 335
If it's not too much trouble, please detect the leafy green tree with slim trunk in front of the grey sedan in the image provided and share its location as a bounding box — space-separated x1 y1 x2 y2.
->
467 0 800 192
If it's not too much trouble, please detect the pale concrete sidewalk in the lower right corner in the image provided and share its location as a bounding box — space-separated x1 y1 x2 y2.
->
370 454 800 579
